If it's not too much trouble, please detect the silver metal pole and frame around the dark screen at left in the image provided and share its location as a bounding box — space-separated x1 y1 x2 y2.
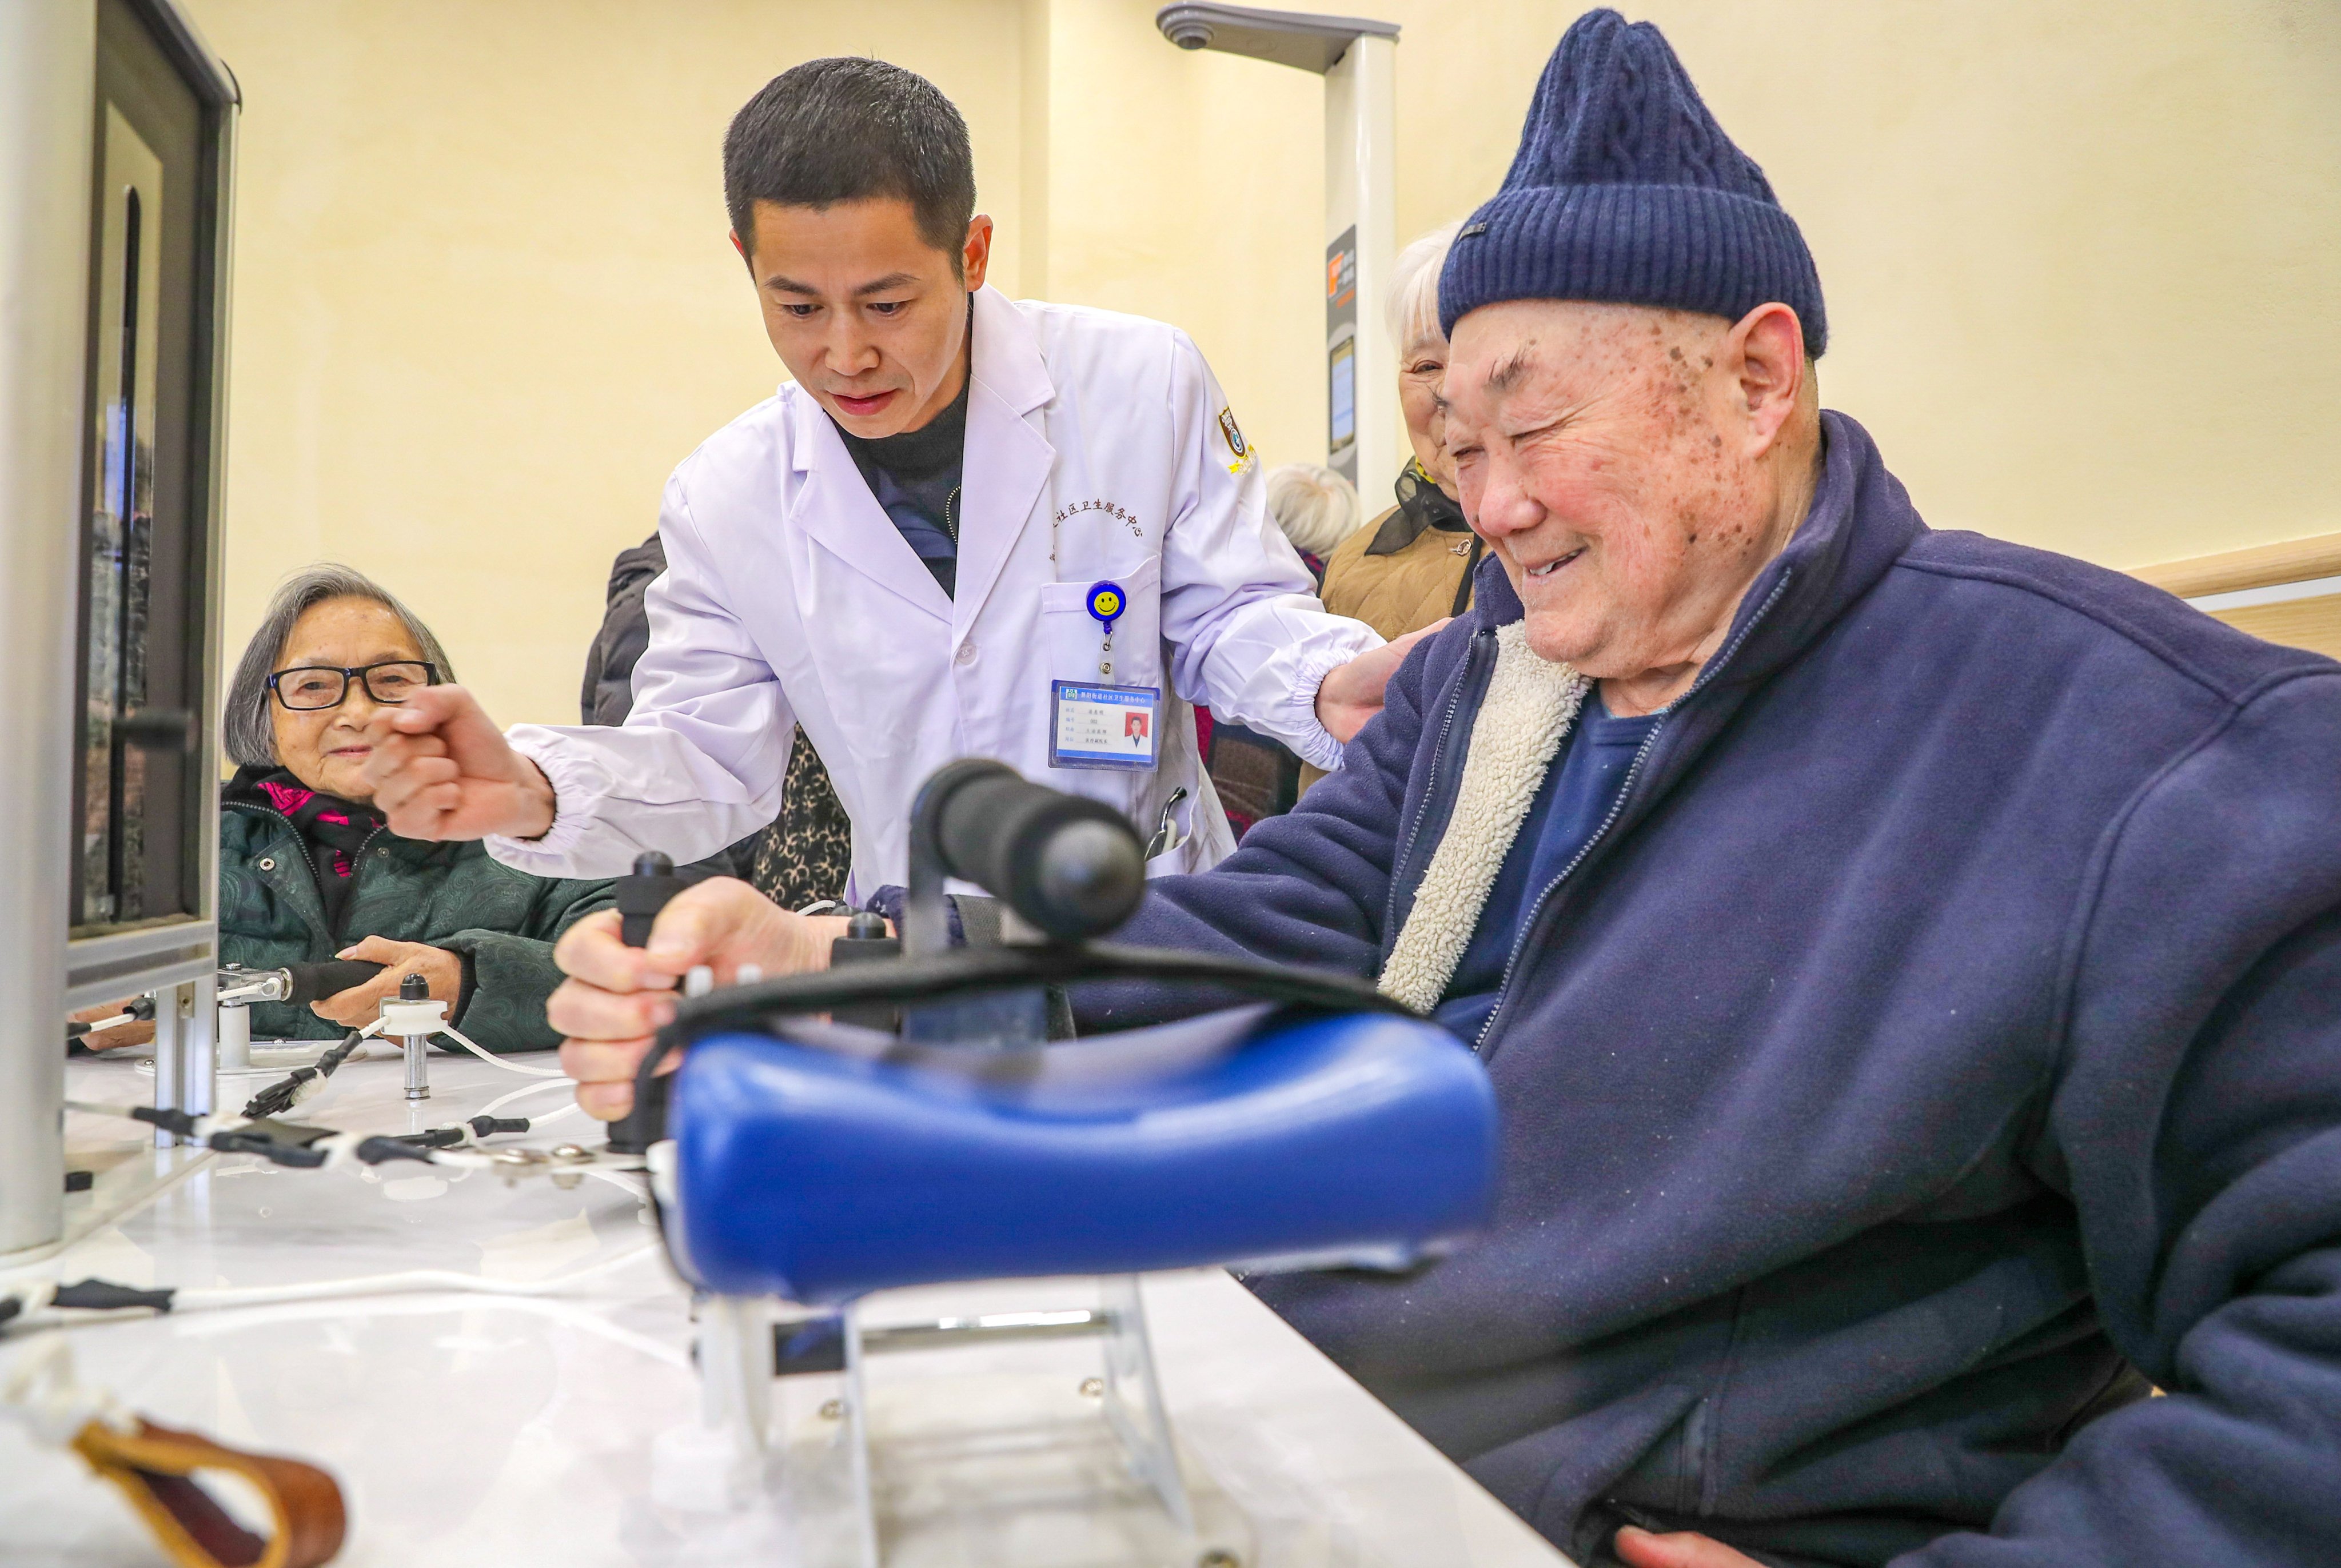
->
0 0 241 1264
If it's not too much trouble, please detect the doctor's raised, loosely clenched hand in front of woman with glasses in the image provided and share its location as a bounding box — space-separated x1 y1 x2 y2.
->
363 686 552 843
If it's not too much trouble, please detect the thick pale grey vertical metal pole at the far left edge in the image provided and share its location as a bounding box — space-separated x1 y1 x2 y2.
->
0 0 98 1262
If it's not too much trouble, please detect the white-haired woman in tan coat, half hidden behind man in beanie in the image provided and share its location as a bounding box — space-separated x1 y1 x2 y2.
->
1318 222 1482 641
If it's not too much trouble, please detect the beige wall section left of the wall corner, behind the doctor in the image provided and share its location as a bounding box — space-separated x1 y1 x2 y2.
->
192 0 1023 723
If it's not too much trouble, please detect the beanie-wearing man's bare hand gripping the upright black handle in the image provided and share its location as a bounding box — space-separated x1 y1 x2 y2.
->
545 877 845 1121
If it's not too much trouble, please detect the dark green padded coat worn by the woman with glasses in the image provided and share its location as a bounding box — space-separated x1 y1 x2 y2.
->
220 770 611 1051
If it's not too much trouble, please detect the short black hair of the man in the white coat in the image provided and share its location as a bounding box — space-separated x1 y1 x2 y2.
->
723 56 976 274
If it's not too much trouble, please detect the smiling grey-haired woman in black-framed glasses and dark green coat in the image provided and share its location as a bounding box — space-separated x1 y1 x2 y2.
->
207 566 611 1051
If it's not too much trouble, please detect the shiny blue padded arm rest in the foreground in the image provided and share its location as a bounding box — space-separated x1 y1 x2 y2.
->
667 1006 1496 1303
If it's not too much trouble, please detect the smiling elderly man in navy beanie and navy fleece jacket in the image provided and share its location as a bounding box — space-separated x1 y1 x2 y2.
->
538 11 2341 1568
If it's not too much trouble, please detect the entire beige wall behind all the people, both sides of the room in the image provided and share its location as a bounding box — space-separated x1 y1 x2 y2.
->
194 0 2341 721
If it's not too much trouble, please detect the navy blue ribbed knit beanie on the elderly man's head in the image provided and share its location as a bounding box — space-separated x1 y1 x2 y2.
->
1439 11 1828 356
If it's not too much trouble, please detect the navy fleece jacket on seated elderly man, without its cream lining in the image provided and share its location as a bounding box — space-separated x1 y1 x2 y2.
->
1082 414 2341 1568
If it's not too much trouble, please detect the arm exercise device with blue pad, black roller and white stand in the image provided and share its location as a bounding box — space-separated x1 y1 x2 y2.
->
637 763 1496 1568
